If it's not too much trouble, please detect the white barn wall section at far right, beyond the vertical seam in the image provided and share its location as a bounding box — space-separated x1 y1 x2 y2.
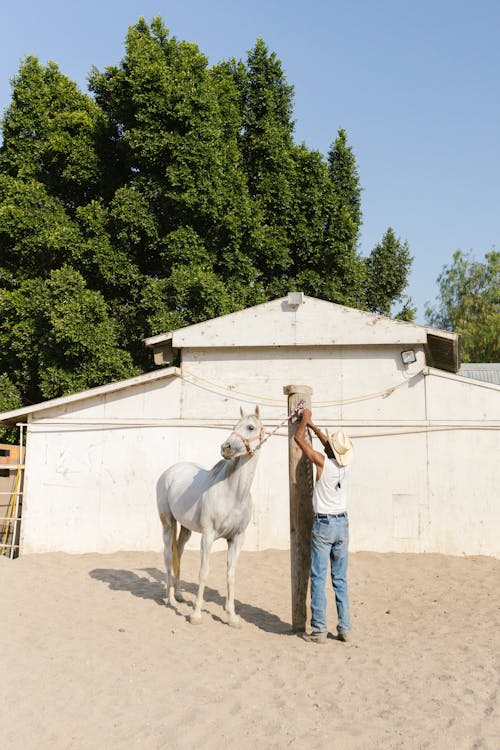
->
426 374 500 557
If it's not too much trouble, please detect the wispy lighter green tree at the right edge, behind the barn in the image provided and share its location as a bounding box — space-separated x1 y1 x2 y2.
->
425 250 500 362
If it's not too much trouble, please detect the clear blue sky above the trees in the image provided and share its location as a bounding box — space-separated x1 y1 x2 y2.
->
0 0 500 323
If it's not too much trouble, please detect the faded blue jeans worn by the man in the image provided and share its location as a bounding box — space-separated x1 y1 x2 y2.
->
311 515 351 635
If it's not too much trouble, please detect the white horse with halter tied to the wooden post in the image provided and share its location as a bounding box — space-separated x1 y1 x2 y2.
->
157 407 264 627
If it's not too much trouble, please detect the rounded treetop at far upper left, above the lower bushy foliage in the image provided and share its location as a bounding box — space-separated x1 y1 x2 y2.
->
0 55 110 207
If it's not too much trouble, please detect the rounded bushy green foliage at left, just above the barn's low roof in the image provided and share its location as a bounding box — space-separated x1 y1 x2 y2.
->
0 266 138 403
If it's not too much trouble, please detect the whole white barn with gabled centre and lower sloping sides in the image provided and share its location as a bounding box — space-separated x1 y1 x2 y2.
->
0 294 500 557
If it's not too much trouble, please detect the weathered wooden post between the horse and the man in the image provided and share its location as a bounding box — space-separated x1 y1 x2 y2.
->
283 385 314 632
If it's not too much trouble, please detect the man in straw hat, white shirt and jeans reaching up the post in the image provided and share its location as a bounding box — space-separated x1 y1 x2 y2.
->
295 409 354 643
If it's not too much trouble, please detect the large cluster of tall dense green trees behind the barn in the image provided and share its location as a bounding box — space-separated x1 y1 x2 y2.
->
0 17 411 424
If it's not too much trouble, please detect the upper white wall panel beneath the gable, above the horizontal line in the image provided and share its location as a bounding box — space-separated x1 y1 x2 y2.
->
181 346 425 421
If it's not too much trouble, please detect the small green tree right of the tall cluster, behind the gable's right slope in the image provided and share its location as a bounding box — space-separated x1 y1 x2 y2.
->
365 227 415 320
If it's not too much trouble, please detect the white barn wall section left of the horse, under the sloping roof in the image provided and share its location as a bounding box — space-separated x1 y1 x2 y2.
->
22 379 185 552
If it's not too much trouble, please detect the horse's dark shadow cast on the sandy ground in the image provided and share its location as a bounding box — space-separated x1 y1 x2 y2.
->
89 568 292 635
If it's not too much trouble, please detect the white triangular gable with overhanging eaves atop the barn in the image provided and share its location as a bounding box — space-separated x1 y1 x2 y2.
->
144 293 459 372
